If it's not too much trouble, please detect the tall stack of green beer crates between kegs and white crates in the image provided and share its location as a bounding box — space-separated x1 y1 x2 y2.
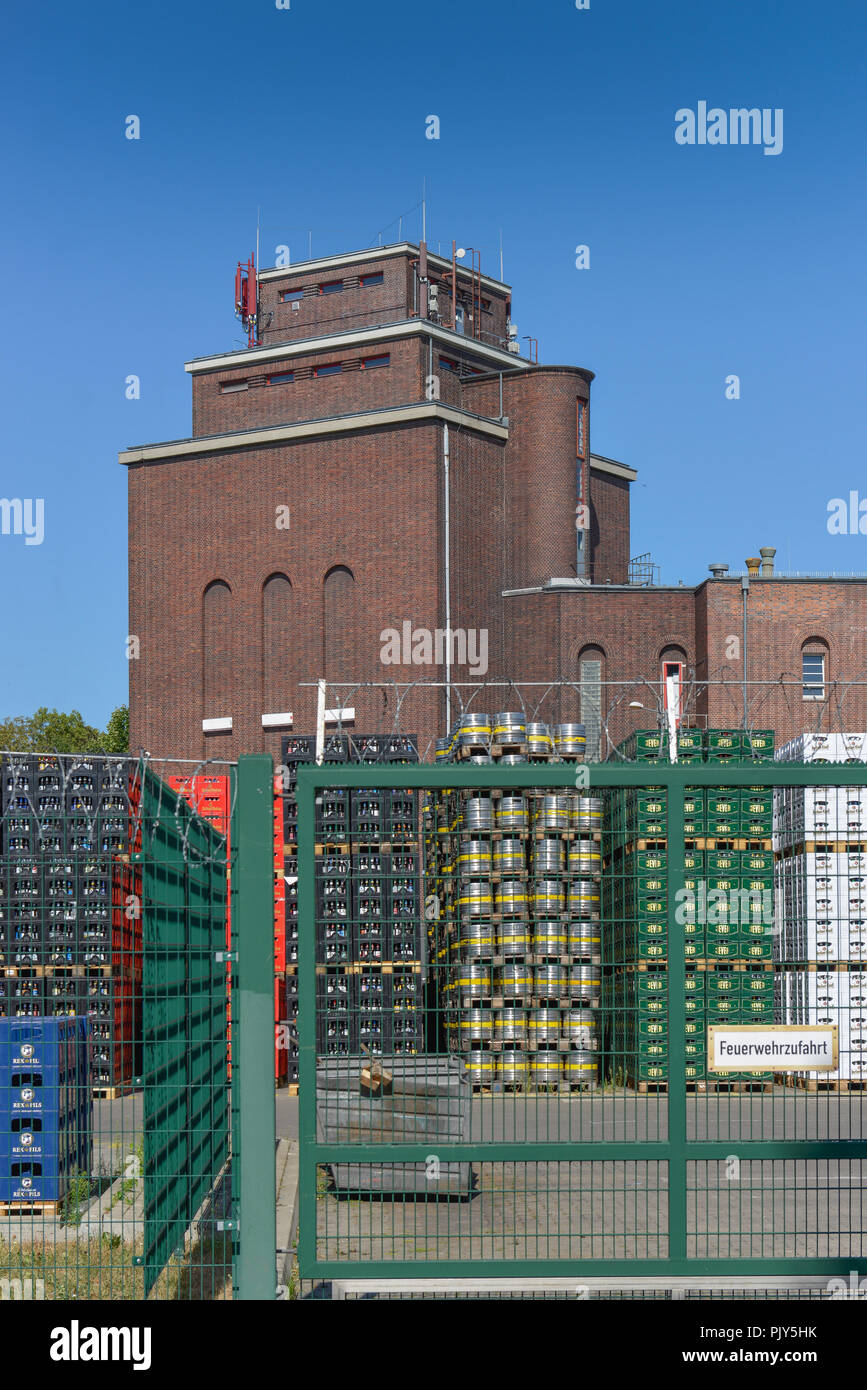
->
602 728 774 1091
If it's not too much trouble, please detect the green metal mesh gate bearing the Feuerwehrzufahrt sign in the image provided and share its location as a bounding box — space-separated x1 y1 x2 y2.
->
297 762 867 1297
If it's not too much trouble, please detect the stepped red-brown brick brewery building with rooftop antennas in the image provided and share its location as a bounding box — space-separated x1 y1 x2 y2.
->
119 243 867 758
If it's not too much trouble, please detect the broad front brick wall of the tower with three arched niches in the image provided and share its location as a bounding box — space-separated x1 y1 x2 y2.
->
129 424 442 758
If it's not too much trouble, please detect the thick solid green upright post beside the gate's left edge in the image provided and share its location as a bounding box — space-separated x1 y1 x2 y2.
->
232 753 276 1300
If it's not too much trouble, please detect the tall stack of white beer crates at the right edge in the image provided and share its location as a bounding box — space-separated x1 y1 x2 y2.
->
774 733 867 1091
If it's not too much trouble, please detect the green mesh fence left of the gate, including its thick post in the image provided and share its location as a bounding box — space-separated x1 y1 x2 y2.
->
0 755 276 1300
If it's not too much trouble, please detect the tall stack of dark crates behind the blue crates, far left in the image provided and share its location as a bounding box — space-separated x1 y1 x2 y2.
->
0 753 142 1094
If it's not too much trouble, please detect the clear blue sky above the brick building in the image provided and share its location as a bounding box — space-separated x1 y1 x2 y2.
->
0 0 867 724
